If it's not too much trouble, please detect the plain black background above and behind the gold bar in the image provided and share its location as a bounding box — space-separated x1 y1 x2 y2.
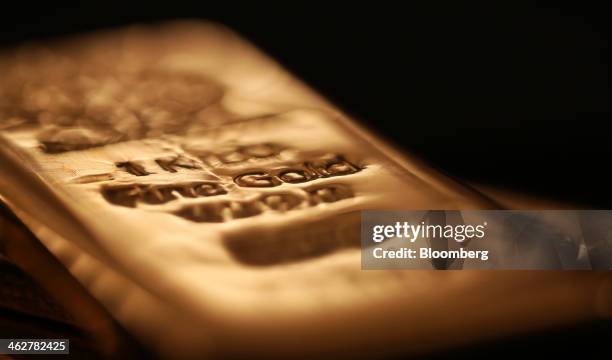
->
0 1 612 208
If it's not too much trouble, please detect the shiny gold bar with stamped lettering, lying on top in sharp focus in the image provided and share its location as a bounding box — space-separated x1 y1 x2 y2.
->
0 23 610 357
